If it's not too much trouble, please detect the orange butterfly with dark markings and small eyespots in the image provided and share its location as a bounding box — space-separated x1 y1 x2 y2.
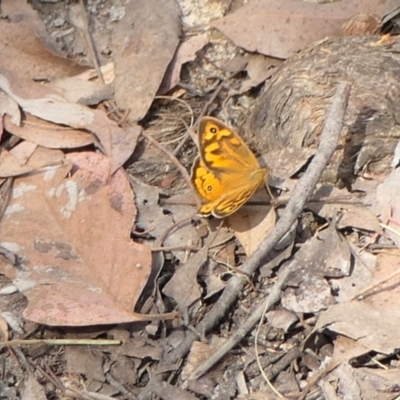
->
191 117 269 218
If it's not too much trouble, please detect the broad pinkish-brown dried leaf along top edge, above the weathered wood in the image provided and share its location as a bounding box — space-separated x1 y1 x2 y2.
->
211 0 398 58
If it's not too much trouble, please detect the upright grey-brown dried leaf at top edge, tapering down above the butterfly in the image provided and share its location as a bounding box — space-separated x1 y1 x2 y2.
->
113 0 181 121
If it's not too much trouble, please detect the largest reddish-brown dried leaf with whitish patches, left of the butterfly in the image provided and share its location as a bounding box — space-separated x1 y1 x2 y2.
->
1 150 151 326
